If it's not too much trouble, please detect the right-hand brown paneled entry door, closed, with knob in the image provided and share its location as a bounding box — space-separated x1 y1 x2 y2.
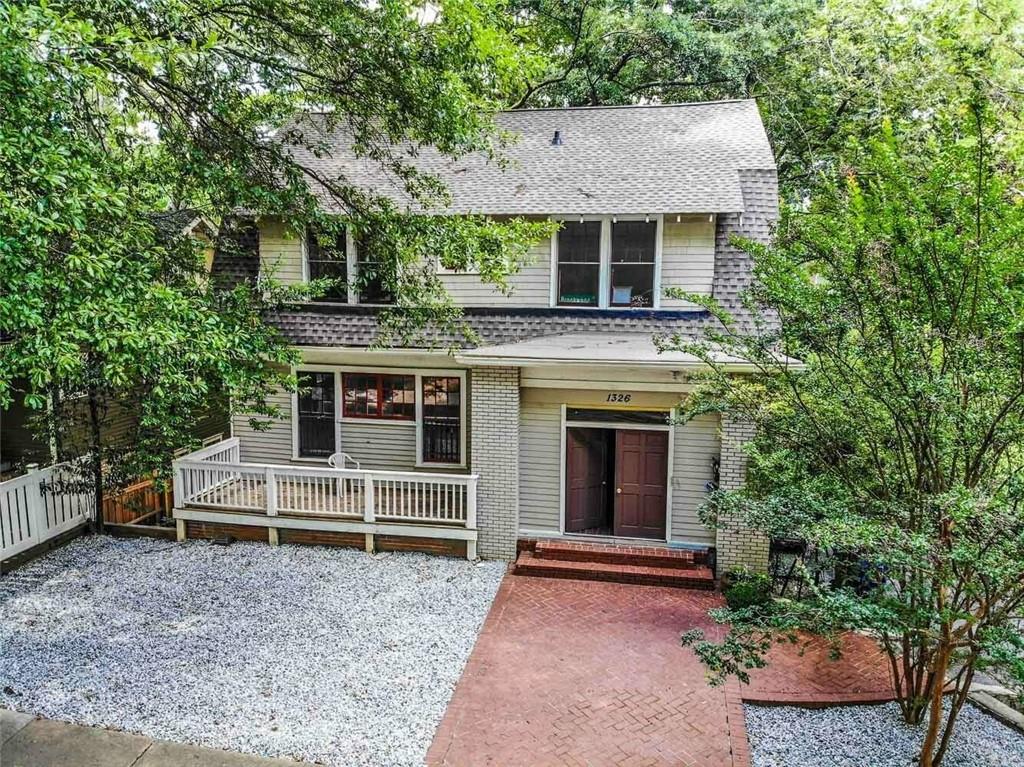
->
614 429 669 540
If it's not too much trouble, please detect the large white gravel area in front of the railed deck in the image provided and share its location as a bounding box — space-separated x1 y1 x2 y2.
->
0 538 505 767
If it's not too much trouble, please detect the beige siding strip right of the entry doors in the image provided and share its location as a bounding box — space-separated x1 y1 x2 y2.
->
672 415 720 544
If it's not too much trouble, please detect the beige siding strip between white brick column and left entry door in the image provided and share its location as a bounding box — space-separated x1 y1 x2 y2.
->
519 401 562 532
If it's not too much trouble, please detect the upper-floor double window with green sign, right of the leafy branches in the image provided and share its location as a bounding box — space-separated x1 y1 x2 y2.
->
552 216 662 308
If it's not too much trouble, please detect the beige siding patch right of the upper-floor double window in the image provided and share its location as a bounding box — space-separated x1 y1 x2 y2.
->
662 215 715 309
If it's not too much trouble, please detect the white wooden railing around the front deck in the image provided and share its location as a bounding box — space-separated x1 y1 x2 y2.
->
174 437 477 555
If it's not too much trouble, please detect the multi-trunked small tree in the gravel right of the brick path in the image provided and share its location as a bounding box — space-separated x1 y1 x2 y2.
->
675 96 1024 767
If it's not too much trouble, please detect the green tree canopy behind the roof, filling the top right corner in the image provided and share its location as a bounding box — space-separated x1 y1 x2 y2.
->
512 0 1024 201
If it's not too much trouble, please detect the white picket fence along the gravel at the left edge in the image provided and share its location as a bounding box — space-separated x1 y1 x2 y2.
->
0 464 96 559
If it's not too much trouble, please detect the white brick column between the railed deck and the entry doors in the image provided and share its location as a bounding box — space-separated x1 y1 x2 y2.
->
469 368 519 559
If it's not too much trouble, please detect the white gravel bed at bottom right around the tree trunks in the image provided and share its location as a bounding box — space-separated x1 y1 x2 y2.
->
743 704 1024 767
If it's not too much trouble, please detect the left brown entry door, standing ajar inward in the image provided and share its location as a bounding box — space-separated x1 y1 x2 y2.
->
565 428 608 532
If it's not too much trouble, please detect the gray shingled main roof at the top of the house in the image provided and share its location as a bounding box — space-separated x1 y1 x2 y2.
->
282 100 775 215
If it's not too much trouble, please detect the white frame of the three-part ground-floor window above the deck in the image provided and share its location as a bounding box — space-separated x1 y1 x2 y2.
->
291 365 469 469
